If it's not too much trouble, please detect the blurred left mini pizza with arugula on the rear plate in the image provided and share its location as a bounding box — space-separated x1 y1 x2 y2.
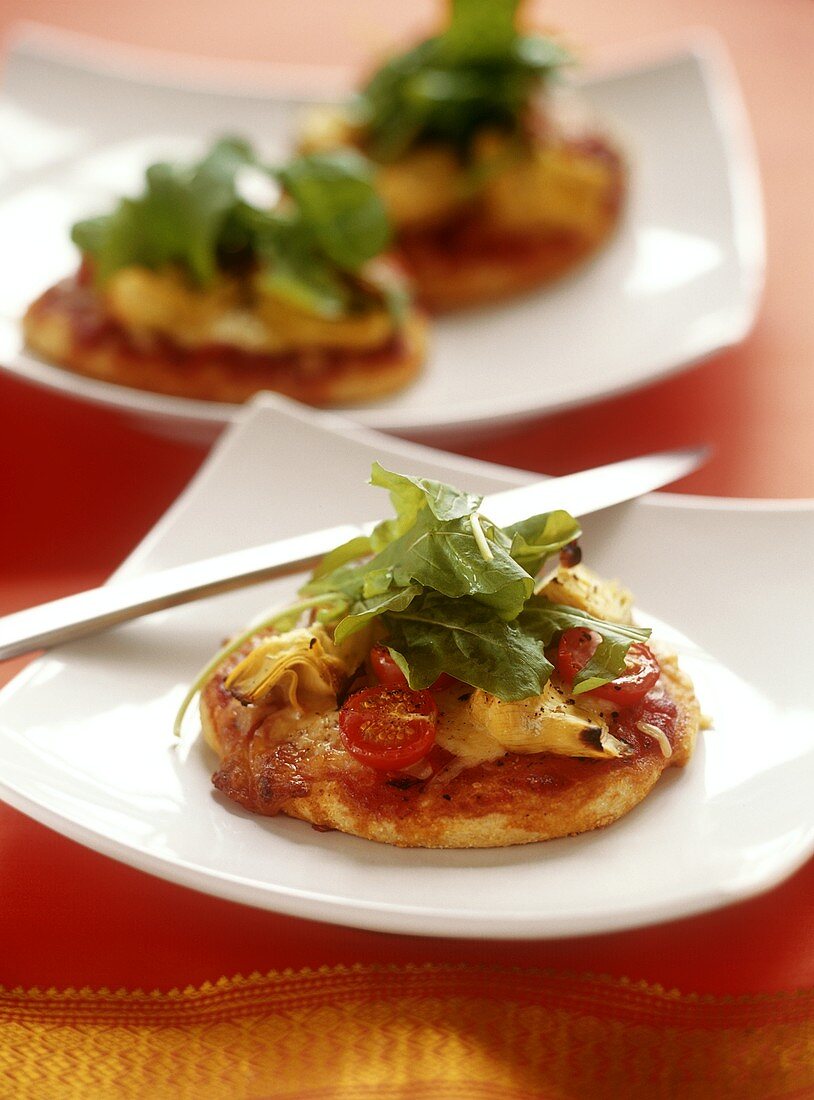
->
24 141 426 406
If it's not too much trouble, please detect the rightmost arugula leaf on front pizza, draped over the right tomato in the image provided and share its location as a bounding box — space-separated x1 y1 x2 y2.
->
518 596 650 695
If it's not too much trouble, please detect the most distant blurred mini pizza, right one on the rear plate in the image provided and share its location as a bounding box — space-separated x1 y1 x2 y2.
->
301 0 626 310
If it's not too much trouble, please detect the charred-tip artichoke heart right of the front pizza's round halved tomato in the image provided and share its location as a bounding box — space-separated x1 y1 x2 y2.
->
470 682 630 760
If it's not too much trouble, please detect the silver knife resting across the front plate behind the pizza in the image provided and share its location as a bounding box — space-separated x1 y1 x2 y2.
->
0 448 707 660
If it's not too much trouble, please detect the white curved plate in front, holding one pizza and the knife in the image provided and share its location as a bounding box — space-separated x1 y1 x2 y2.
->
0 398 814 937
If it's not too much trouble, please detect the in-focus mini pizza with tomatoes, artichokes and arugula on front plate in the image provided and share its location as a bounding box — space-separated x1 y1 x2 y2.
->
177 465 700 848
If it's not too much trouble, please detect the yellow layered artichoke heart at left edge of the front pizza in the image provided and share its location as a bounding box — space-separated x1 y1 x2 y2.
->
226 625 370 713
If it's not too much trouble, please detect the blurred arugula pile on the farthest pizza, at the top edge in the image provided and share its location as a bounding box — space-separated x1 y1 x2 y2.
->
355 0 572 162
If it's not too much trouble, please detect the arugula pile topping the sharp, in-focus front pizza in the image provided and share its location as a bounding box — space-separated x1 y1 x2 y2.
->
300 463 650 701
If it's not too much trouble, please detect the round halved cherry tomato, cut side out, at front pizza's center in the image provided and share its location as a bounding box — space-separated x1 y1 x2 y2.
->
339 688 438 771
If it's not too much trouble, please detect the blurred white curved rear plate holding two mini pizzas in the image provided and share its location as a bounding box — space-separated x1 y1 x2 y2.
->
0 26 763 439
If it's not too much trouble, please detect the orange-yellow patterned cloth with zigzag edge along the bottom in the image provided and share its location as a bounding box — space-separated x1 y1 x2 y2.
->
0 965 814 1100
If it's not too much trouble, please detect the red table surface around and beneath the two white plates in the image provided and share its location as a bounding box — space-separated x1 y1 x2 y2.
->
0 0 814 994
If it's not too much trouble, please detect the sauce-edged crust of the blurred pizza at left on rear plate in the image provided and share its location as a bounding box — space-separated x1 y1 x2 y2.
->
23 279 427 406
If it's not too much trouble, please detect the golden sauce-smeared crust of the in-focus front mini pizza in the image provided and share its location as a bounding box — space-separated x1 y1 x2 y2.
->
200 638 701 848
